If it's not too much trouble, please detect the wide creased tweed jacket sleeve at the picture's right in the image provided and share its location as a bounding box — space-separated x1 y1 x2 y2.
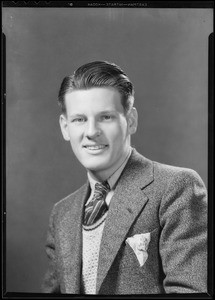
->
159 169 207 293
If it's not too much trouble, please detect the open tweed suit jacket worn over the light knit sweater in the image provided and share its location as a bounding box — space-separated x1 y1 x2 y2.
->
42 149 207 295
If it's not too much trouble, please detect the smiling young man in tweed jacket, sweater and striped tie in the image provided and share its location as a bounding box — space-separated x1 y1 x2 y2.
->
43 61 207 295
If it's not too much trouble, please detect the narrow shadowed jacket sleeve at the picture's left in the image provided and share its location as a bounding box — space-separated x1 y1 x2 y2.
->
42 207 61 294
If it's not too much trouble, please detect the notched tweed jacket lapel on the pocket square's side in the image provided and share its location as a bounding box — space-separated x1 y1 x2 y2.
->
97 150 153 293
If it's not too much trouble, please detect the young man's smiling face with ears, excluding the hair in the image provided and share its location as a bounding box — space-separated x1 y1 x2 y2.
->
60 87 137 180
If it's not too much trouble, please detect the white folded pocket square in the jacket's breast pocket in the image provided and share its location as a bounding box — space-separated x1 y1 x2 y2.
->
126 232 151 267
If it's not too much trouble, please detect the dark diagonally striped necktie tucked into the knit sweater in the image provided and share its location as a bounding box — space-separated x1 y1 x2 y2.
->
84 181 110 225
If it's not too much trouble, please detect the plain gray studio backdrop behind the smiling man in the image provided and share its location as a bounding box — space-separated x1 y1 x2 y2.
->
2 8 213 292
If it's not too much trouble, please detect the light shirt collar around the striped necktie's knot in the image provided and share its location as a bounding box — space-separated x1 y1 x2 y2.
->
87 147 132 190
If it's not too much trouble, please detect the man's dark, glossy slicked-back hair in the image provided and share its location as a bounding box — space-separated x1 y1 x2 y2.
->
58 61 134 115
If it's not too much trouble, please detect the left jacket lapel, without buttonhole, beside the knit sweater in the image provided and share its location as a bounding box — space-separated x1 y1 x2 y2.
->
60 184 89 294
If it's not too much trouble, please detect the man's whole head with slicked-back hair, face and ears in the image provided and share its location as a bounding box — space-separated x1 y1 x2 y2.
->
59 62 137 180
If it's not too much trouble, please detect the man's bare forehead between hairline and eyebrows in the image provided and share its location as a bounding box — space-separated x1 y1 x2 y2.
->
65 87 124 112
